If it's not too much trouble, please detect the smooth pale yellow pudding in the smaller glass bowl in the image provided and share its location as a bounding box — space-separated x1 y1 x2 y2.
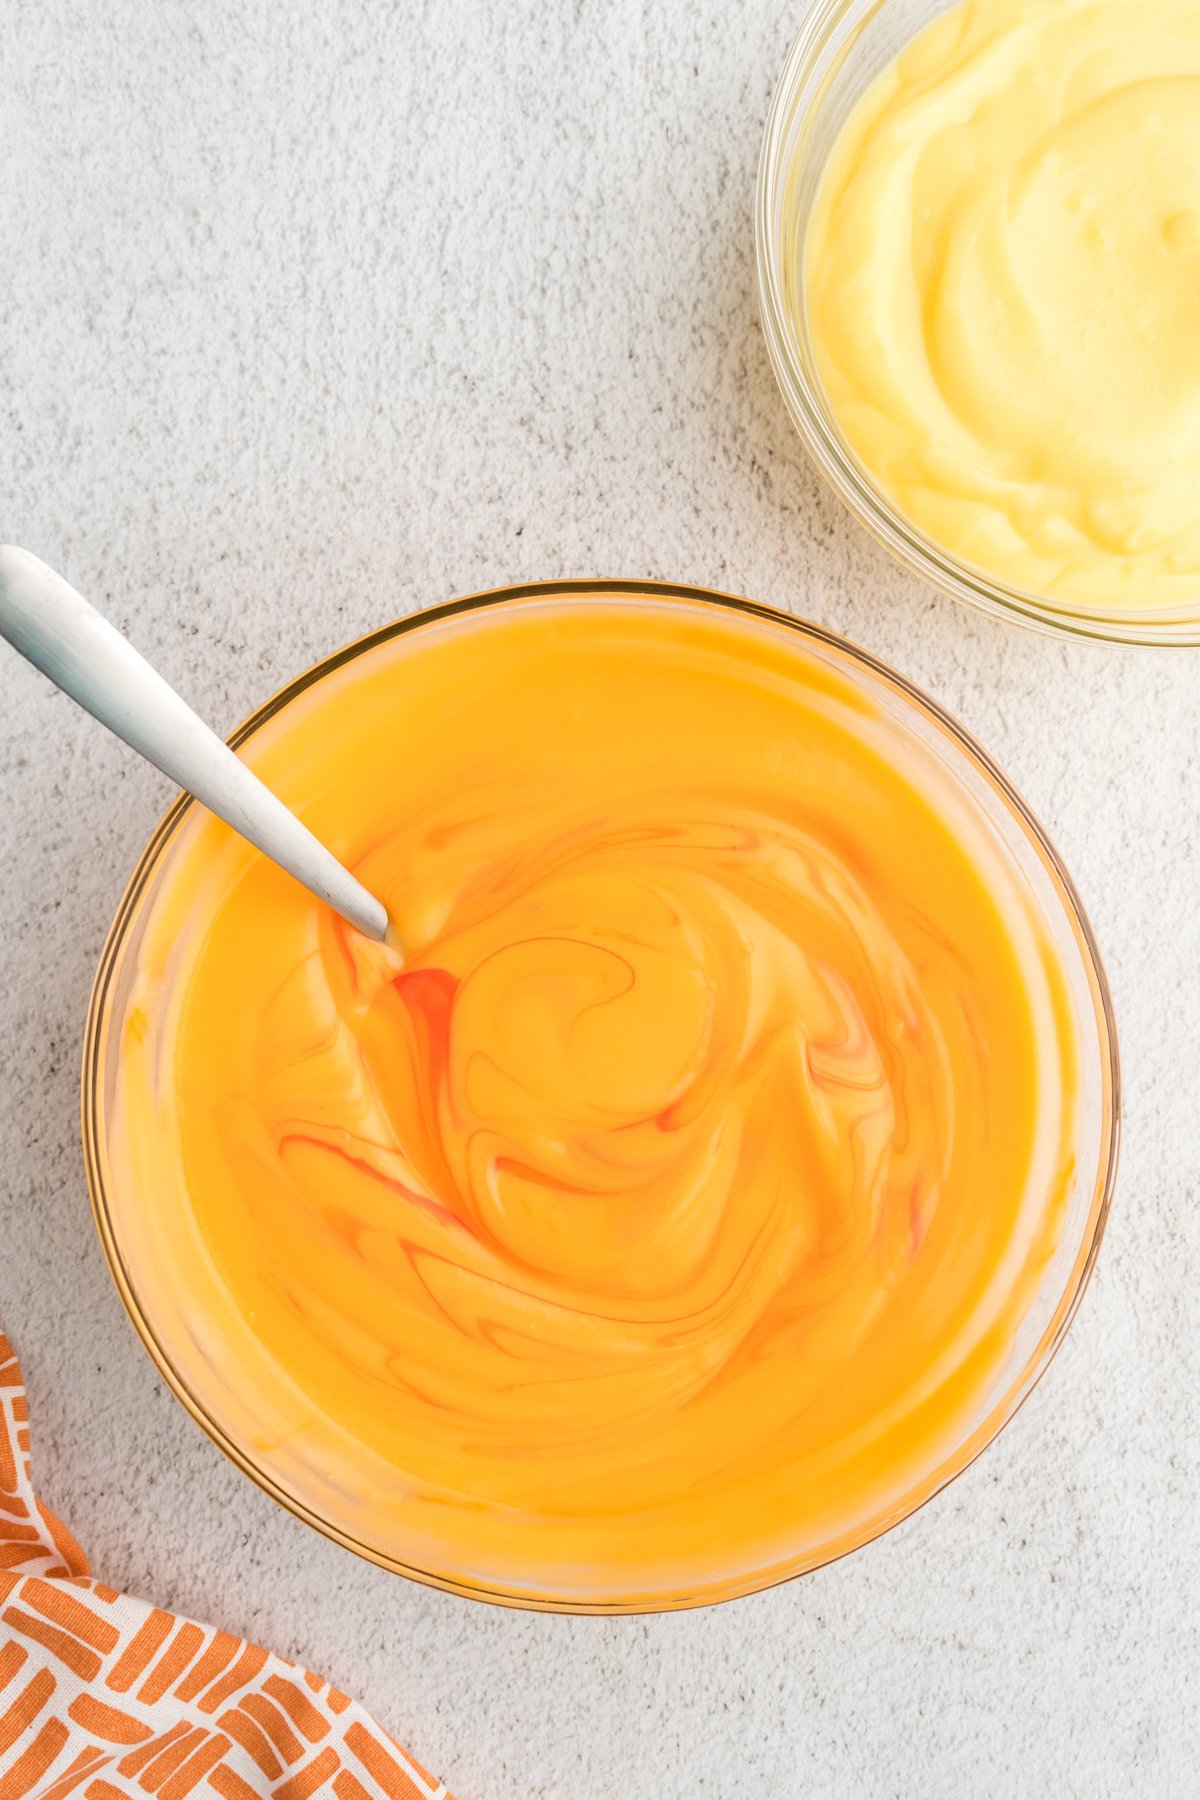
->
793 0 1200 614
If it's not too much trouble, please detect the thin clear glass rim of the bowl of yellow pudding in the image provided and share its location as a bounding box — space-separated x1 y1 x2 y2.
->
754 0 1200 650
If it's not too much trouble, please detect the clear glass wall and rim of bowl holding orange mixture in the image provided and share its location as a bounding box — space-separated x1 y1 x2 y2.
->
83 581 1119 1613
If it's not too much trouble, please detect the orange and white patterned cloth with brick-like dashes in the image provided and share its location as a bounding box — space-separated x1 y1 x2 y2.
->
0 1336 450 1800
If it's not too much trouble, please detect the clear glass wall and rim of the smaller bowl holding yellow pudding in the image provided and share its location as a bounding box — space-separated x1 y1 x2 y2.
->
754 0 1200 646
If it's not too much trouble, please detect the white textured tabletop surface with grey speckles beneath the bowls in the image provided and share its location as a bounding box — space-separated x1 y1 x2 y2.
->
0 0 1200 1800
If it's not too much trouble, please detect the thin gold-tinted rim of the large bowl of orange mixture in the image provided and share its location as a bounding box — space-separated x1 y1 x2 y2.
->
81 578 1121 1616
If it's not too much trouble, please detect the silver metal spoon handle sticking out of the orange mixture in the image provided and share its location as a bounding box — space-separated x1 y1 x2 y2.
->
0 544 387 938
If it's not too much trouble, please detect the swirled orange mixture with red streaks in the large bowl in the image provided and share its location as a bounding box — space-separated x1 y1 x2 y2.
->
100 599 1076 1602
